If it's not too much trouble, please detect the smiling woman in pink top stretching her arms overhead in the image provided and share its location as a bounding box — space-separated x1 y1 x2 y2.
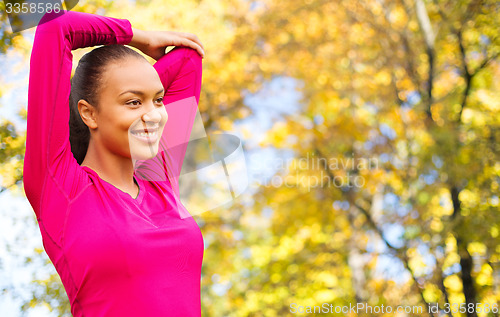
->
24 11 204 317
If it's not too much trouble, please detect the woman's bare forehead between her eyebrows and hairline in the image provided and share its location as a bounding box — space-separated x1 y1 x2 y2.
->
102 58 163 95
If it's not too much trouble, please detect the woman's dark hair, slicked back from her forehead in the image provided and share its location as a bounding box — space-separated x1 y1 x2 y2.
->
69 44 147 164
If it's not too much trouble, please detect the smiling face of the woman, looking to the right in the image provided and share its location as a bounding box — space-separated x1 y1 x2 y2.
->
93 57 168 162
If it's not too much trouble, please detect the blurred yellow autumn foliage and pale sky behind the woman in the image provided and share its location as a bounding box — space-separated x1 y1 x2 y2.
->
0 0 500 317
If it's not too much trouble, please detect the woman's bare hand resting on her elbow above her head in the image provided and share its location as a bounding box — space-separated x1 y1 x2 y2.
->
129 28 205 60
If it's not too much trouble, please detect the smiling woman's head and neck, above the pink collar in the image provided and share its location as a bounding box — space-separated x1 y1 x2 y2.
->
75 51 168 183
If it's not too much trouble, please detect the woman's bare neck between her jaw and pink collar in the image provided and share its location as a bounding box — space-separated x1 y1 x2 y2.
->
81 138 137 197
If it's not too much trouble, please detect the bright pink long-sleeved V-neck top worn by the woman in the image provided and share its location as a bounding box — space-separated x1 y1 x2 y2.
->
24 11 204 317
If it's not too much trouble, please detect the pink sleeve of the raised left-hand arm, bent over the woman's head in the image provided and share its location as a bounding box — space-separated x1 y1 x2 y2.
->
24 11 133 217
